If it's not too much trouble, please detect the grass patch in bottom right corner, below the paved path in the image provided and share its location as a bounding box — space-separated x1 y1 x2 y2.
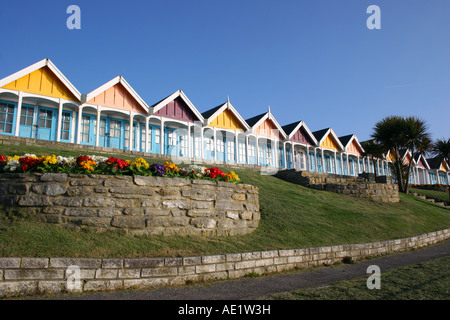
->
270 257 450 300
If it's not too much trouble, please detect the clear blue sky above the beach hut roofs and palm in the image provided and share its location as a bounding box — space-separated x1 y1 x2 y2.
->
0 0 450 141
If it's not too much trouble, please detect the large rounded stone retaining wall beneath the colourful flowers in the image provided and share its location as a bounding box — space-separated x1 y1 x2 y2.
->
0 173 260 236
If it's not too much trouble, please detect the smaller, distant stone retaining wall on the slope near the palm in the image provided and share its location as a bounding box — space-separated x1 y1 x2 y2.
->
275 170 400 202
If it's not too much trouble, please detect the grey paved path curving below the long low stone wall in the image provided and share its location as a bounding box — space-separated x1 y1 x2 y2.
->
52 240 450 300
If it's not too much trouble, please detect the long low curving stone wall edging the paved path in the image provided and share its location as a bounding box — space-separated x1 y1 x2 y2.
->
0 229 450 297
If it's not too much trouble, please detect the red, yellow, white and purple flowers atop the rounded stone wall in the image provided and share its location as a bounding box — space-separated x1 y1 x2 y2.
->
0 154 241 183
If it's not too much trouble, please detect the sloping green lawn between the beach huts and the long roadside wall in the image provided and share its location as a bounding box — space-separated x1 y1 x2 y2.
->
0 145 450 258
